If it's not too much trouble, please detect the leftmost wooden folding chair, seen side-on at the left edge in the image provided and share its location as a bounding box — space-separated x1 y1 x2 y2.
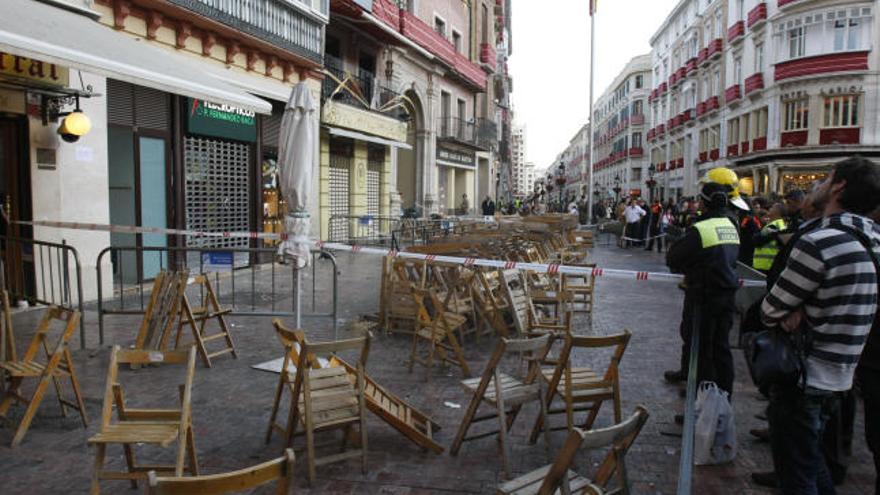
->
0 306 88 447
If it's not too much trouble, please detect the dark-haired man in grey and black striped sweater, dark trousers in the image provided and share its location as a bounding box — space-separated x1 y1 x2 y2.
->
761 157 880 495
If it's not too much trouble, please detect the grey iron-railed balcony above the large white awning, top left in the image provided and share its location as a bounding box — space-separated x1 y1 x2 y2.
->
167 0 330 63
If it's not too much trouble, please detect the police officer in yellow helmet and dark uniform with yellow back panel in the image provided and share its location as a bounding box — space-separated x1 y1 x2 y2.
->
666 167 748 400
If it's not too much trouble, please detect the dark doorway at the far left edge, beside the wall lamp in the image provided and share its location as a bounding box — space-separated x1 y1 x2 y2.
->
0 116 35 297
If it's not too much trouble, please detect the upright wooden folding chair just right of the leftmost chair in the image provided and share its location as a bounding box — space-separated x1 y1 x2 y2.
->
89 346 199 495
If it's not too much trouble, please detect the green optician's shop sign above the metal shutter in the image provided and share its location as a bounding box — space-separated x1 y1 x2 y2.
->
186 98 257 142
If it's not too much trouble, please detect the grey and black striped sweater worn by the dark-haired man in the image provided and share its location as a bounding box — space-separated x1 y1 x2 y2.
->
761 213 880 391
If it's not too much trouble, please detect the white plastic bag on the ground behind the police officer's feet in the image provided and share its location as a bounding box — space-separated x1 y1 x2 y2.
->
694 382 736 465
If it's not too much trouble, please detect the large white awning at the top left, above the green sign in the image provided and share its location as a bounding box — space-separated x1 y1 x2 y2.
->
0 0 272 114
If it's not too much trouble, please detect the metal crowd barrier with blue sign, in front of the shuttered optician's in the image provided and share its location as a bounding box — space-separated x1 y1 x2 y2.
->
96 246 339 345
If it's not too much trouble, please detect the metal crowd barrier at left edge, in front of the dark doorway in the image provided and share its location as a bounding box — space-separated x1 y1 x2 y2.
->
0 236 86 349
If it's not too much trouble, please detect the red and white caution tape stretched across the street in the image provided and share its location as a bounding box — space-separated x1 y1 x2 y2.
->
16 220 766 287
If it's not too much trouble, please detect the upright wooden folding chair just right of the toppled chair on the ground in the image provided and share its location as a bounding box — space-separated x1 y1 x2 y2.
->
450 335 550 476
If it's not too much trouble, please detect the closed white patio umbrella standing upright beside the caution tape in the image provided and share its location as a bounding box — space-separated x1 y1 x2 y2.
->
278 82 316 268
